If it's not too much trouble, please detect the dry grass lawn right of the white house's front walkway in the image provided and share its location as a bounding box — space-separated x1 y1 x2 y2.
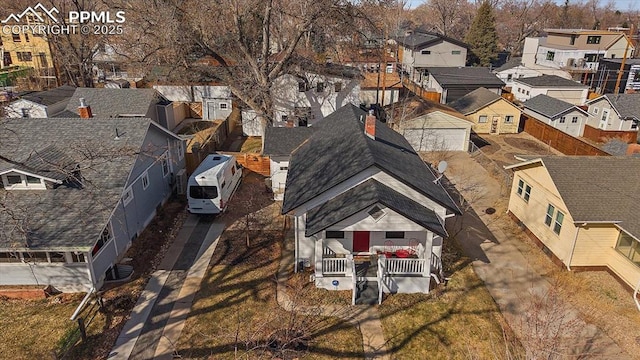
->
380 242 522 359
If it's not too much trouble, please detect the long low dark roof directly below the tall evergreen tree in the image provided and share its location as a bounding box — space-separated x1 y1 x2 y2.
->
427 67 505 88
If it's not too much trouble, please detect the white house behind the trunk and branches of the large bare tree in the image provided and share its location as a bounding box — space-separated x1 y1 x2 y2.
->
242 61 362 136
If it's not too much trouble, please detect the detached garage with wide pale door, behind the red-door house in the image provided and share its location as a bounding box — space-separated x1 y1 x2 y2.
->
399 111 472 151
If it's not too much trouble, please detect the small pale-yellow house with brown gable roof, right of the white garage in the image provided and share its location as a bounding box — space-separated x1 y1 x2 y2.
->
449 87 522 134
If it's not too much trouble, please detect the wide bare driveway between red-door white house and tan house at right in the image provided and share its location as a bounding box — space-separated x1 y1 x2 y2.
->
446 153 631 359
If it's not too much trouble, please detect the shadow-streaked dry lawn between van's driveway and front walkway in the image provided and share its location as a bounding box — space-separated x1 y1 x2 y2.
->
179 231 362 358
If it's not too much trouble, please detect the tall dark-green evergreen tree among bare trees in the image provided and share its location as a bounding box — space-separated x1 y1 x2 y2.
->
465 0 498 66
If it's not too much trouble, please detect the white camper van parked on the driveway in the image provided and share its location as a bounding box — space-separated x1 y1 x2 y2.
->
187 154 242 214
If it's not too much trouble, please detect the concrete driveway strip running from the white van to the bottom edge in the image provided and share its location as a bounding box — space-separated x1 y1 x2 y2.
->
108 215 224 360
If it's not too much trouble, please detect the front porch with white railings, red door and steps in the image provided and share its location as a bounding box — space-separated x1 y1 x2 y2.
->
307 231 443 304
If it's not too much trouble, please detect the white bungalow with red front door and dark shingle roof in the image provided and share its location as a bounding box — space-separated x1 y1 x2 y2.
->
282 105 461 304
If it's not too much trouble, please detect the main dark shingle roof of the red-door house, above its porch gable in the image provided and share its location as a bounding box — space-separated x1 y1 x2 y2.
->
282 104 460 214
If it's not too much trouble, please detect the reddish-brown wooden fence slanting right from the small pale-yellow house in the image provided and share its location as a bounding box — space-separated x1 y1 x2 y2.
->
522 114 610 156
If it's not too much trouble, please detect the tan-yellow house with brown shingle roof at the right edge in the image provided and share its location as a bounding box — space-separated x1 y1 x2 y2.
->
506 156 640 289
